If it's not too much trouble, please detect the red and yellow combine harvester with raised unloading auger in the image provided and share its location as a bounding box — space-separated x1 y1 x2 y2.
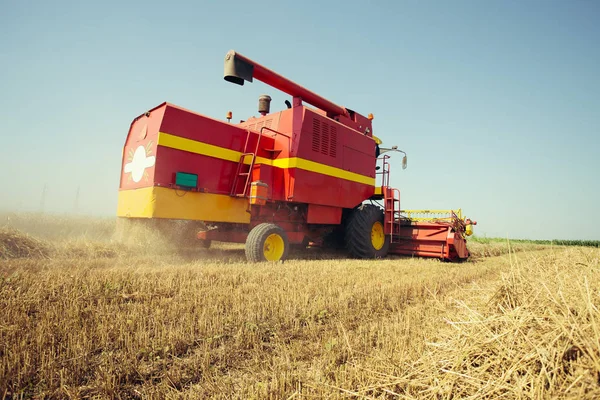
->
117 51 476 262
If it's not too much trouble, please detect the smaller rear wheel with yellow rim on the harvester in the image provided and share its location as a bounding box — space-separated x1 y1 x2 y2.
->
246 223 290 262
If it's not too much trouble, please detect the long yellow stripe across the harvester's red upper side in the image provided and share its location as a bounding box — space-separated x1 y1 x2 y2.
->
158 132 375 186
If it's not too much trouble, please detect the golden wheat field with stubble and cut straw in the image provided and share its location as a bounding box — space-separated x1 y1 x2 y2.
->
0 216 600 399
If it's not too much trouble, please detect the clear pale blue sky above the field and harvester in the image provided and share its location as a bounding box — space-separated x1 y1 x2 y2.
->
0 0 600 239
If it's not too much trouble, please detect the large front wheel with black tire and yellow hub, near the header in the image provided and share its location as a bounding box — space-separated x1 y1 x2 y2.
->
344 204 390 258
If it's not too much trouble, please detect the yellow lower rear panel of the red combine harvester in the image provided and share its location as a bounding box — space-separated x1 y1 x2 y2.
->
117 186 250 223
